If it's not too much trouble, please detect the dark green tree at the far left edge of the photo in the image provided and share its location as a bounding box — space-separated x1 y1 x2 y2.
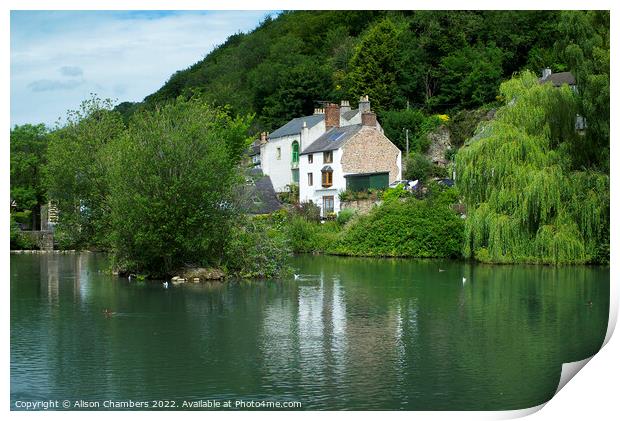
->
10 124 48 228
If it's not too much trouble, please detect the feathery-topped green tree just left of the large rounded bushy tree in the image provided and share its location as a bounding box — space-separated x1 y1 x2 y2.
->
45 96 124 247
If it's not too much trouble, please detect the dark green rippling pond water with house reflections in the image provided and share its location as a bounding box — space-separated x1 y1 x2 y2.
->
10 253 609 410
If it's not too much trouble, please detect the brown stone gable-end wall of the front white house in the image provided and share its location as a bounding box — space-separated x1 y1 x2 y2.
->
340 127 400 183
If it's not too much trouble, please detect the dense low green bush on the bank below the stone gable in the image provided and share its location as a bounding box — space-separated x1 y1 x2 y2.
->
328 192 463 257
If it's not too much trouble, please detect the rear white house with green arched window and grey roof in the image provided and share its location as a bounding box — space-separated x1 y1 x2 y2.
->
260 96 382 192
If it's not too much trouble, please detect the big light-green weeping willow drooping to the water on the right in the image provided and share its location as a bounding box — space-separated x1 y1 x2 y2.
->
456 73 609 264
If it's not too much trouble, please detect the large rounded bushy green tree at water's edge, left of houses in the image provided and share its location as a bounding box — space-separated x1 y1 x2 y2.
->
105 98 254 275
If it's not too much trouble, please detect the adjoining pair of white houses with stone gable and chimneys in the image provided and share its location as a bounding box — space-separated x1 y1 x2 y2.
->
258 96 401 216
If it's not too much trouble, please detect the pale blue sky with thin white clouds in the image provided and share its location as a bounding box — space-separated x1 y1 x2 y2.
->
10 11 273 128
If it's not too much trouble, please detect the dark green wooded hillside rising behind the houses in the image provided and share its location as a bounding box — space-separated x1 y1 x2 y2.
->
119 11 567 130
